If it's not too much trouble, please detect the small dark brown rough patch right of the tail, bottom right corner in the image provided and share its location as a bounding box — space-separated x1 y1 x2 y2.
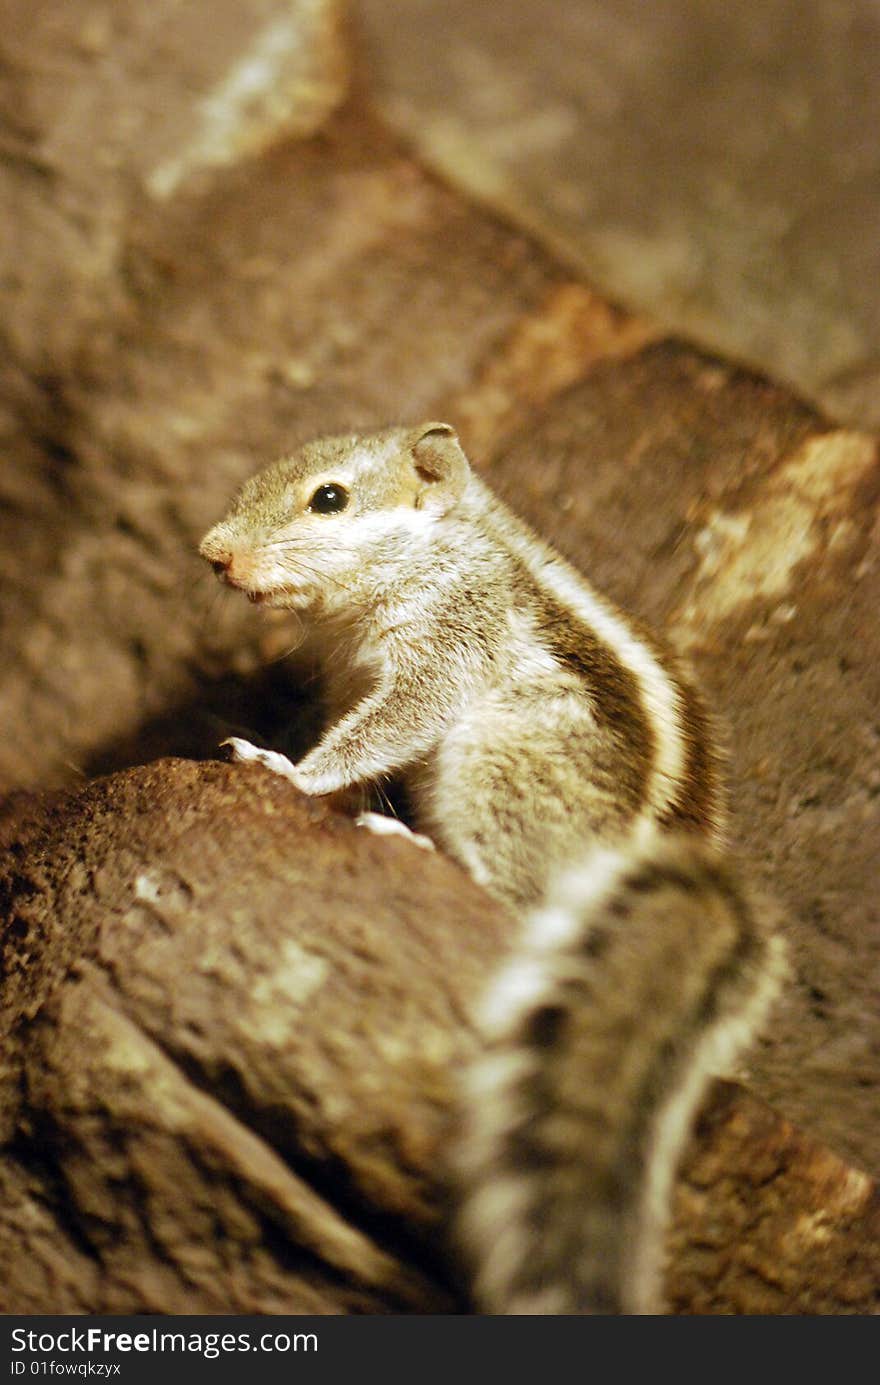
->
667 1083 880 1316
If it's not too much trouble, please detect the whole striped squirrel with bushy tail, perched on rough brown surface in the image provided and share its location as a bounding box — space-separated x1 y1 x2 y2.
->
200 422 783 1314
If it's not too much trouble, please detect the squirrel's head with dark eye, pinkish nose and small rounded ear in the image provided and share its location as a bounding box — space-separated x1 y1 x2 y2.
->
198 422 470 608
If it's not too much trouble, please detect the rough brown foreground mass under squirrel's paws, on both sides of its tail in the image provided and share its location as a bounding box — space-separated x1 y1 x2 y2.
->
0 760 879 1313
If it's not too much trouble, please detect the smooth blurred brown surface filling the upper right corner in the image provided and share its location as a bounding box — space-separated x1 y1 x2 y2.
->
355 0 880 427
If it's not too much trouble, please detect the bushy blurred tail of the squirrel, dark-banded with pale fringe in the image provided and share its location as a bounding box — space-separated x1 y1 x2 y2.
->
455 834 784 1314
